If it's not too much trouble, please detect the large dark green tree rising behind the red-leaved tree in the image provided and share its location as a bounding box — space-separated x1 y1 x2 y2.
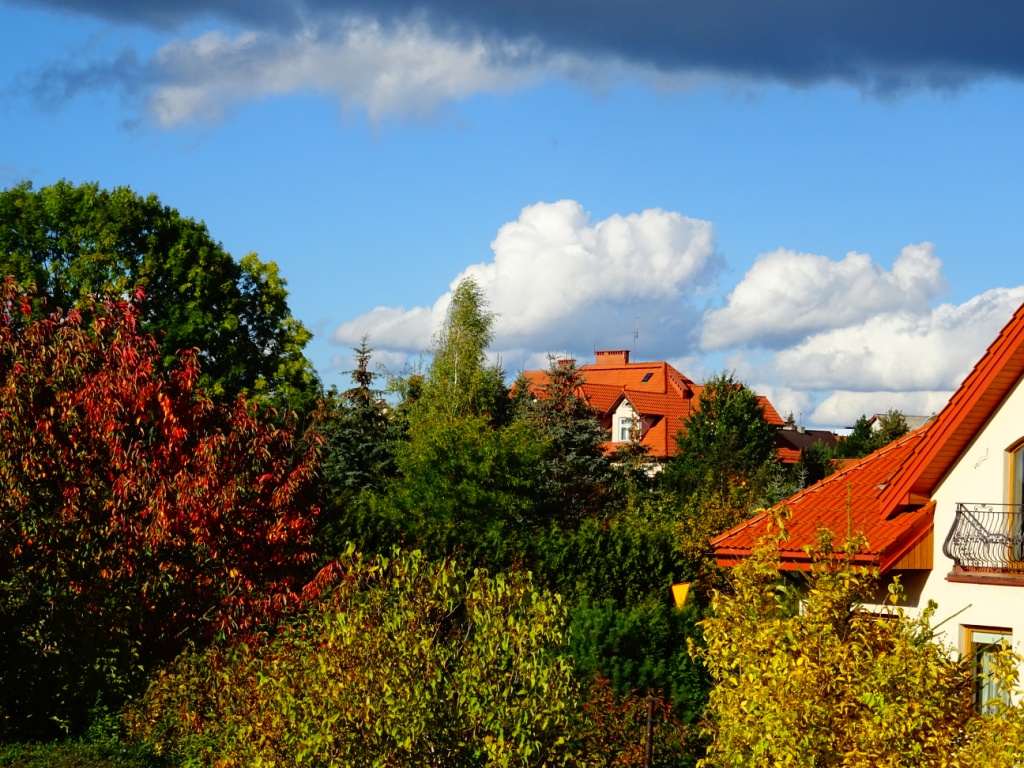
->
0 181 319 412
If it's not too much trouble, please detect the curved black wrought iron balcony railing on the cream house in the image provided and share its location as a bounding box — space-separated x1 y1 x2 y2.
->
942 503 1024 573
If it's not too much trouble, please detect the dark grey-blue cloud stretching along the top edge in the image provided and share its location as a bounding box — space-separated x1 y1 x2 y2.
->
12 0 1024 92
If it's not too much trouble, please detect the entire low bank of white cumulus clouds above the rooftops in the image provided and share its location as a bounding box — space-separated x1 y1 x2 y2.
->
332 200 1024 427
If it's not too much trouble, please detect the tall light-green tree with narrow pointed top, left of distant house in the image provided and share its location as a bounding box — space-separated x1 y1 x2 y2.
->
370 279 546 567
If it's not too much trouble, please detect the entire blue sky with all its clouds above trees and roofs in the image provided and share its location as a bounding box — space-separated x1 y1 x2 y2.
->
0 0 1024 427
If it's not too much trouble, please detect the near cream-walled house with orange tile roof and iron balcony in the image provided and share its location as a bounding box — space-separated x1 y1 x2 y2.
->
712 306 1024 708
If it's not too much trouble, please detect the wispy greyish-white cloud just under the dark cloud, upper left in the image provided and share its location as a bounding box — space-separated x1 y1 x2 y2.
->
147 19 557 128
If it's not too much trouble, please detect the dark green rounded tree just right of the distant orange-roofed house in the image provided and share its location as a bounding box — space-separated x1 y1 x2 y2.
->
663 374 775 495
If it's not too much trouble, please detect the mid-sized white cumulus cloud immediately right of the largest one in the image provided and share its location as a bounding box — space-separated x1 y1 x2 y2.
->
701 243 946 349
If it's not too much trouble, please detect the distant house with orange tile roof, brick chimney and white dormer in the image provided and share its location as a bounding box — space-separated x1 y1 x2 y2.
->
524 349 786 460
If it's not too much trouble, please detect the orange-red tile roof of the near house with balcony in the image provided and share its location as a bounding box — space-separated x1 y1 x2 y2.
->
712 305 1024 569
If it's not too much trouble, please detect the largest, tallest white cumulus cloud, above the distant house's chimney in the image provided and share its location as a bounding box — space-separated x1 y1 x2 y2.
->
332 200 719 359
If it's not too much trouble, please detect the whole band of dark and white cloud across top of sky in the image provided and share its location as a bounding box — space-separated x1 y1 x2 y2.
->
18 0 1024 126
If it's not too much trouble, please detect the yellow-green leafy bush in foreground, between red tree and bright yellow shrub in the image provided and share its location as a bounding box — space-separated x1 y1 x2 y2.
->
132 552 598 768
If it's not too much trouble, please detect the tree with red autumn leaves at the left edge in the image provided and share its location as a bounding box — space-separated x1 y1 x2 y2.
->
0 279 319 738
